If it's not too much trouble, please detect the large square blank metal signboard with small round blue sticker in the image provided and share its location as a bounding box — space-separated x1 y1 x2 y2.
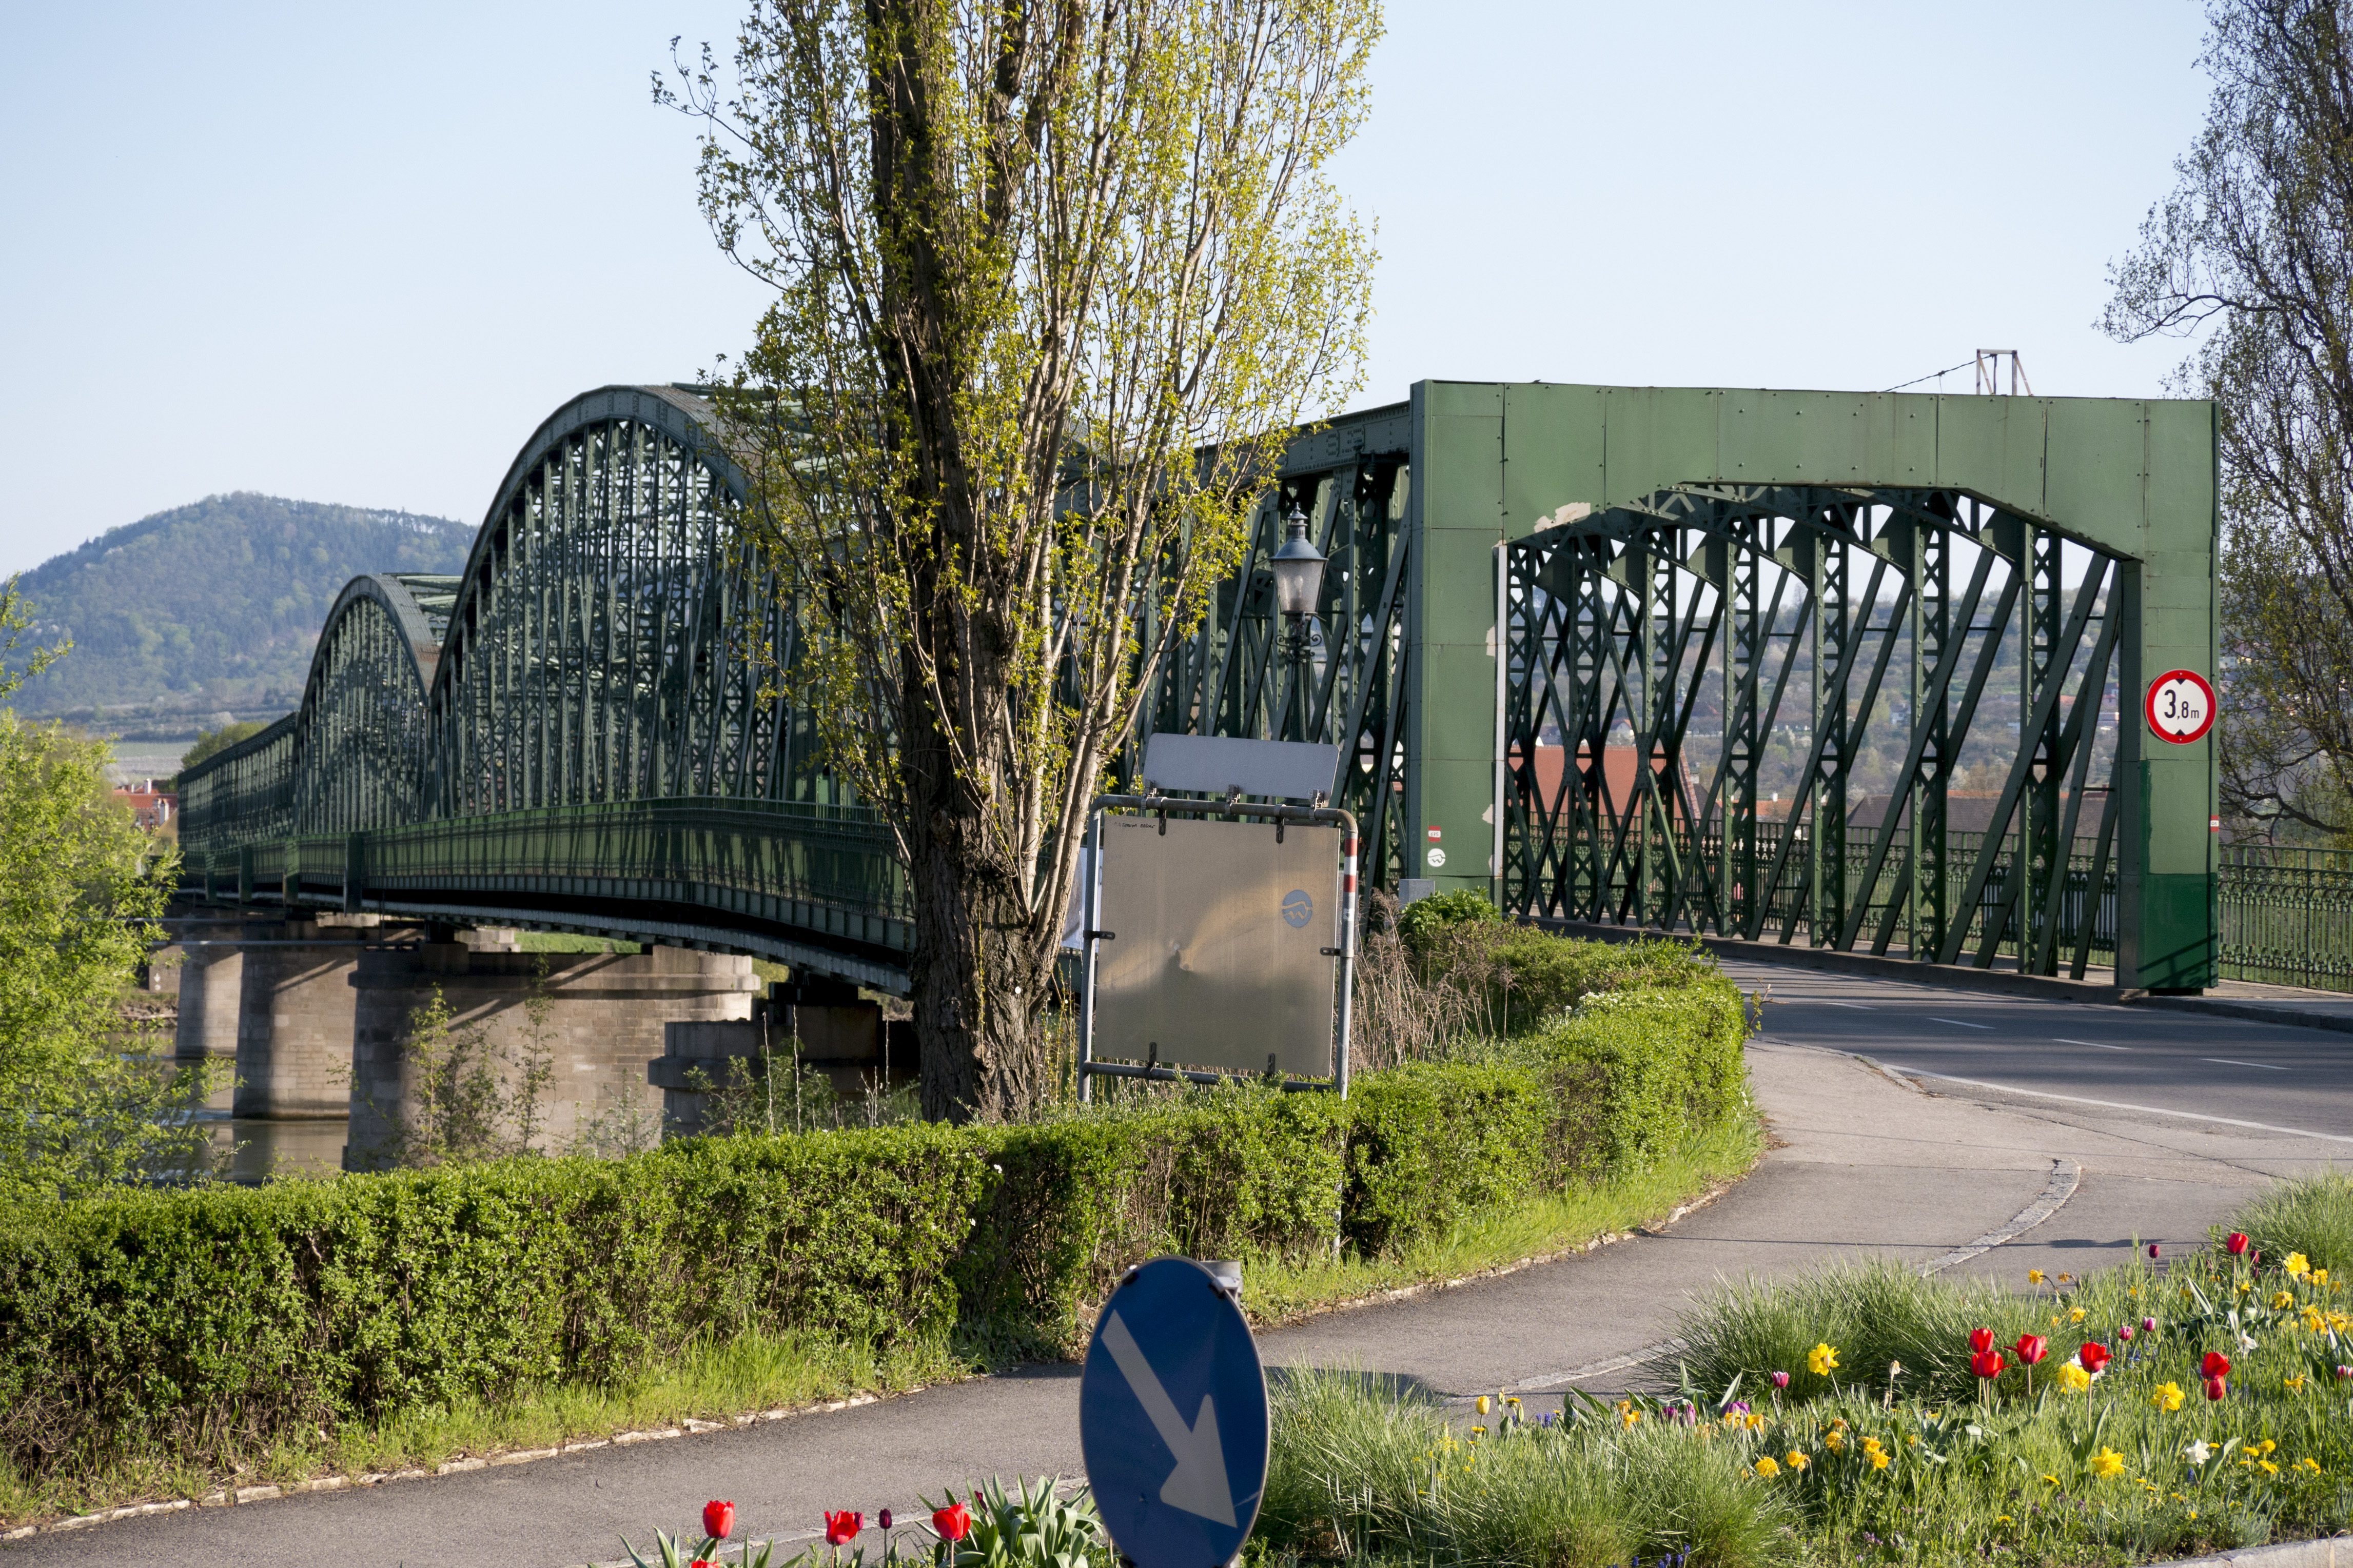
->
1089 816 1341 1077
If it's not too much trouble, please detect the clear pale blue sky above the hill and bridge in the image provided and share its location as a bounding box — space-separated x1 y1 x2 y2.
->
0 0 2205 571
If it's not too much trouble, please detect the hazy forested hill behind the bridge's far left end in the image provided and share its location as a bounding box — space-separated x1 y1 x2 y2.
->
16 491 473 717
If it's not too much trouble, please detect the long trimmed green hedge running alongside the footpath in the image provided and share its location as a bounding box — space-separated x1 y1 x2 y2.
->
0 959 1743 1476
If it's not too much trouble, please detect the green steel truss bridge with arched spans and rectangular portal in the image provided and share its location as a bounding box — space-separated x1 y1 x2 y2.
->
181 381 2249 990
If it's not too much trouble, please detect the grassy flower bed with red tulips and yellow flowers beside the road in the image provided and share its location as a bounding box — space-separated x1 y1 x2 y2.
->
1259 1178 2353 1568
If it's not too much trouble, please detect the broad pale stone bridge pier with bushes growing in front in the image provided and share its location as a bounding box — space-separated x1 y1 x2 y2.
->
344 943 760 1170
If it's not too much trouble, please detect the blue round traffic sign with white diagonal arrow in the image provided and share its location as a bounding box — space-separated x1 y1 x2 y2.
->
1077 1258 1266 1568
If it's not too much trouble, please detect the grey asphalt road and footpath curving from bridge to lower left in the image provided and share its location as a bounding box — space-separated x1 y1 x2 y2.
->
18 964 2353 1568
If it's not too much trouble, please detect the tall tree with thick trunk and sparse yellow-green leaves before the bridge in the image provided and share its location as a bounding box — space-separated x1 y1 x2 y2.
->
654 0 1381 1117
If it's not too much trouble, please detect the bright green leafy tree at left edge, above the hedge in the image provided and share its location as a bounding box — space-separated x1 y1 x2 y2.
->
0 578 217 1204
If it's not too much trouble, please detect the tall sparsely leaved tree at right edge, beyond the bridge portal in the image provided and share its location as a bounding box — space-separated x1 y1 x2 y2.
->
2101 0 2353 835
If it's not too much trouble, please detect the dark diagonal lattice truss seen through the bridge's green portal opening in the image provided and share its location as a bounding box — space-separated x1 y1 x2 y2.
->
1501 484 2123 976
